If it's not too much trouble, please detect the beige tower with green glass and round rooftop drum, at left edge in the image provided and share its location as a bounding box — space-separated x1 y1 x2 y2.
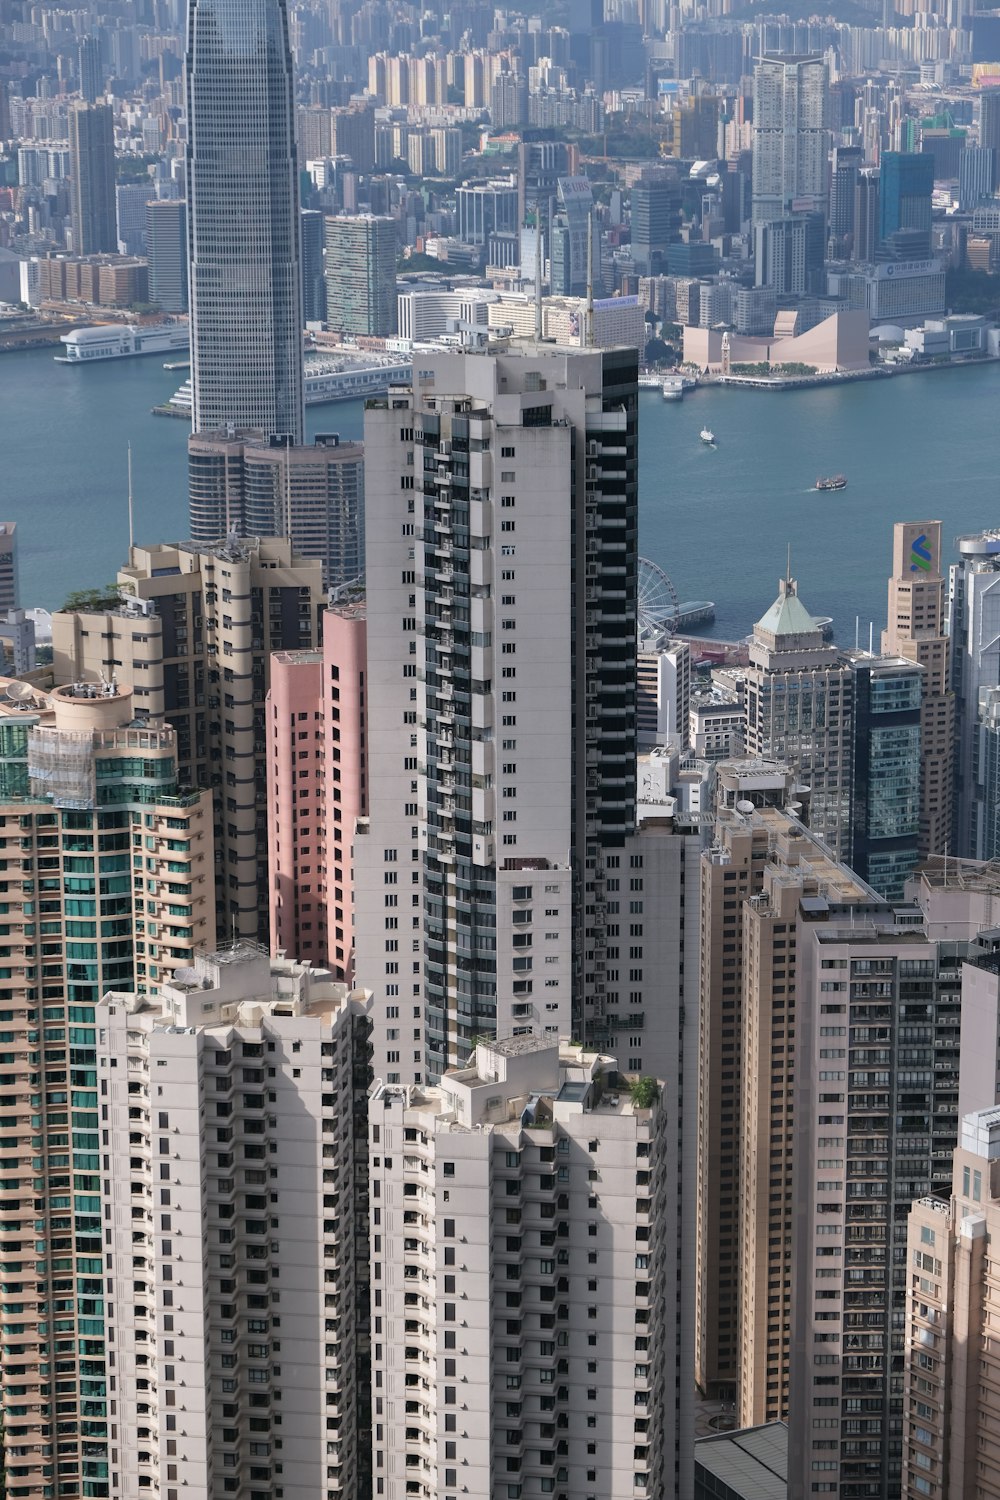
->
0 683 216 1500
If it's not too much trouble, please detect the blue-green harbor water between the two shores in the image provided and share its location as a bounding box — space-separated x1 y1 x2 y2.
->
0 350 1000 644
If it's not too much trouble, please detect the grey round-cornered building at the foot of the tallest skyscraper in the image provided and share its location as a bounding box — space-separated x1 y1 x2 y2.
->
187 432 364 588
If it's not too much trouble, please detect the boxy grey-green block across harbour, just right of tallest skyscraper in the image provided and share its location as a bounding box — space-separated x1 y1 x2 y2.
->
325 213 396 339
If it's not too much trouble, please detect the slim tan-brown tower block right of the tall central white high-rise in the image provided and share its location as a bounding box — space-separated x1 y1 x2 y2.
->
696 792 879 1425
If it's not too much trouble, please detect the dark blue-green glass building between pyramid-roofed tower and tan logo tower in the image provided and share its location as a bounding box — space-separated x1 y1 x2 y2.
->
849 656 937 902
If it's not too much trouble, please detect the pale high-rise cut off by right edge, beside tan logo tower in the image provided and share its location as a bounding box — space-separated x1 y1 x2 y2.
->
948 531 1000 860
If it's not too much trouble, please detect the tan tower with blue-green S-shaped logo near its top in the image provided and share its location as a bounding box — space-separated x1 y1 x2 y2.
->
882 521 955 858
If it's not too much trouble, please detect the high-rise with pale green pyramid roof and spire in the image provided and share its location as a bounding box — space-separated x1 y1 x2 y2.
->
745 578 852 860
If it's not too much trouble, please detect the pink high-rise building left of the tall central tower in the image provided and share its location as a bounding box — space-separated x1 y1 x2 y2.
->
267 605 367 978
